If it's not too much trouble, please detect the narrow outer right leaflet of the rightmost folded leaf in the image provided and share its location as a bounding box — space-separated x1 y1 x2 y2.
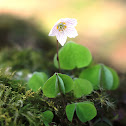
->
108 67 119 90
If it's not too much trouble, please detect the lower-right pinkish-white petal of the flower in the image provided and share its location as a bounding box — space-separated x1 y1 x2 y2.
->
65 27 78 38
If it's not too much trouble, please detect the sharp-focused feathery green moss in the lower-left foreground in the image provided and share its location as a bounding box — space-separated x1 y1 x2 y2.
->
0 70 54 126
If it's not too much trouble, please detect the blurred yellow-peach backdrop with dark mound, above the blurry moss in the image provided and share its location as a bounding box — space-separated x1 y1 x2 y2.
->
0 0 126 73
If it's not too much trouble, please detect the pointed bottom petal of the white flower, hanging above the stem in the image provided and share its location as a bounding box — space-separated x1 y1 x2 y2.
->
56 32 67 46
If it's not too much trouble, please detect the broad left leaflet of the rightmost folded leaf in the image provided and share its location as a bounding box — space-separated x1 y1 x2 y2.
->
79 65 101 90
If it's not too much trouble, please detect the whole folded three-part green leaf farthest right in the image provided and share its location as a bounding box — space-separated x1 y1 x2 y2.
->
79 64 119 90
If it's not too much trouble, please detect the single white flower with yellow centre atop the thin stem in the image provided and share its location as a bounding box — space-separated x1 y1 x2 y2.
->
49 18 78 46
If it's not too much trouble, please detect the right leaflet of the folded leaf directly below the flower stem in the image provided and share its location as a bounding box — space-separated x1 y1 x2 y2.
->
58 73 73 93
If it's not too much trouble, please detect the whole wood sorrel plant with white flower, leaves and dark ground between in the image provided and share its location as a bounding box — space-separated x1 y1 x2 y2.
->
28 18 119 126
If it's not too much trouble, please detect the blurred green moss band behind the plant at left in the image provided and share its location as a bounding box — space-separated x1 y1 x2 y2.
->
0 48 55 75
